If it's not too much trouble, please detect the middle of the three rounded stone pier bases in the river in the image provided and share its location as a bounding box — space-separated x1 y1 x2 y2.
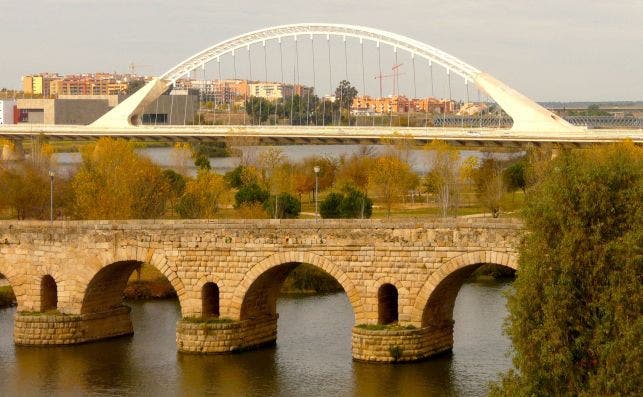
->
176 316 278 354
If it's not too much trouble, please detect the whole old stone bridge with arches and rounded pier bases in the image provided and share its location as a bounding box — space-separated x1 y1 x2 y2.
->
0 218 522 361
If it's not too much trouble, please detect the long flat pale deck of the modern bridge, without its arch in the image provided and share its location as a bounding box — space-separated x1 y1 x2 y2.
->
0 124 643 147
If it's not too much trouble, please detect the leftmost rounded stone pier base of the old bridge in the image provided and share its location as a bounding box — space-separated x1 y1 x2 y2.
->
13 306 134 346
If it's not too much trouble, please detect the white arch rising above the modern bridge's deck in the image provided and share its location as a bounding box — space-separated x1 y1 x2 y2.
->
92 23 584 133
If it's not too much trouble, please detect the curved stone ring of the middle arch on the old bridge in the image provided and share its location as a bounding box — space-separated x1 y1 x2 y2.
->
228 251 363 322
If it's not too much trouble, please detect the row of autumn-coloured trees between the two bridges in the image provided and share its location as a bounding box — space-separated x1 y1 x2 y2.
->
0 137 525 219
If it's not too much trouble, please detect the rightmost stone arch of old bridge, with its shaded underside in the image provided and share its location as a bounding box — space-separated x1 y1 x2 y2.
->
411 251 518 327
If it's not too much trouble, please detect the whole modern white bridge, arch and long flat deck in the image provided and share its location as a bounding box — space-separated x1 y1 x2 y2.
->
0 23 643 152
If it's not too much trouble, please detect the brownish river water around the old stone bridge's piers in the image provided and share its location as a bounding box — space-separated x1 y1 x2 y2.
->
0 281 511 397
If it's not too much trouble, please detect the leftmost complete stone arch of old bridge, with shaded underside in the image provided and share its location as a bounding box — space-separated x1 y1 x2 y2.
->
79 247 185 314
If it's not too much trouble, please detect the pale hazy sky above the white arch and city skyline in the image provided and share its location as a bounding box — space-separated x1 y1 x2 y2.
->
0 0 643 101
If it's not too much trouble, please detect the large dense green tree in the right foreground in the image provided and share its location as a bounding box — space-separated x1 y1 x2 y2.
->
492 143 643 396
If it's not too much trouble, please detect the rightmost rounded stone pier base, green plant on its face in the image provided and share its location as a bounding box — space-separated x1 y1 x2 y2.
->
353 324 453 363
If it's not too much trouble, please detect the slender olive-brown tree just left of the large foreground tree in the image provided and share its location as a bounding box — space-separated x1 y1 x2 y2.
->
474 157 505 218
